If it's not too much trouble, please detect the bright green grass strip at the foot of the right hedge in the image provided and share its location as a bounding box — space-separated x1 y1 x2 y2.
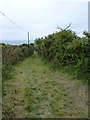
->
42 58 90 85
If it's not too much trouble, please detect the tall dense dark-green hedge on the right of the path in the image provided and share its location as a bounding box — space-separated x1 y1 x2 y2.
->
35 29 90 82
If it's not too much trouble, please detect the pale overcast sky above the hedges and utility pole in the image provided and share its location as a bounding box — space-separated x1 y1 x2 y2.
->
0 0 88 44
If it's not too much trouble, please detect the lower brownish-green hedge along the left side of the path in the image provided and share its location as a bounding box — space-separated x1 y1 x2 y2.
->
2 44 34 80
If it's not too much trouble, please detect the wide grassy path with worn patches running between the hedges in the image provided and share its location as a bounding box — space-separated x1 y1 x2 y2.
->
3 55 88 118
